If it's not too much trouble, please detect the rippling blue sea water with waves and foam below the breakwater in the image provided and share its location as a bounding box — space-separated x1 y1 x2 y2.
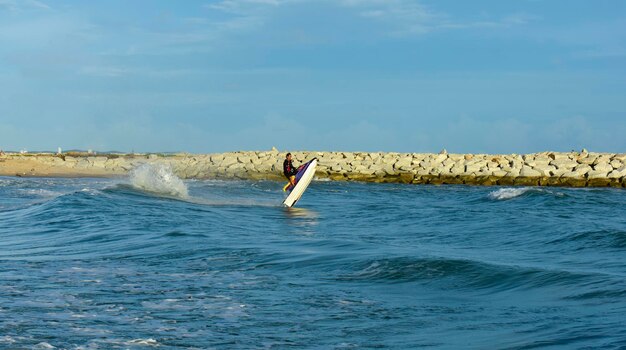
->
0 167 626 349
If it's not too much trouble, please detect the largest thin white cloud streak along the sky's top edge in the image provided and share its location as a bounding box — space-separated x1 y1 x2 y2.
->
194 0 537 42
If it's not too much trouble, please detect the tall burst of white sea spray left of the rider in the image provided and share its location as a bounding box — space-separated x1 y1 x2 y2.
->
130 164 189 198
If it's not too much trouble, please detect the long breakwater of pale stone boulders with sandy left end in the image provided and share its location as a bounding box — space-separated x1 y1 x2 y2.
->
0 149 626 187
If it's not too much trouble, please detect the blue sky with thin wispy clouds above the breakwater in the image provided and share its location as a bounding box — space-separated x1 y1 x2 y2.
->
0 0 626 153
